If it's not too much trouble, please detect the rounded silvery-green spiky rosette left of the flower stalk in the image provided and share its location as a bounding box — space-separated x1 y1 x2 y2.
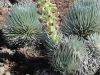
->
2 3 42 45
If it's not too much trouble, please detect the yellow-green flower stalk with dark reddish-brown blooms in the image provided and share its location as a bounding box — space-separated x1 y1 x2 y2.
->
38 0 57 43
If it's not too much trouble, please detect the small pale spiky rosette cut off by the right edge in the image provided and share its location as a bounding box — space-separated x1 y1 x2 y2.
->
88 33 100 49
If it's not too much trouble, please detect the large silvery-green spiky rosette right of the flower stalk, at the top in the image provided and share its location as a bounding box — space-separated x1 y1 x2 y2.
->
62 0 100 38
